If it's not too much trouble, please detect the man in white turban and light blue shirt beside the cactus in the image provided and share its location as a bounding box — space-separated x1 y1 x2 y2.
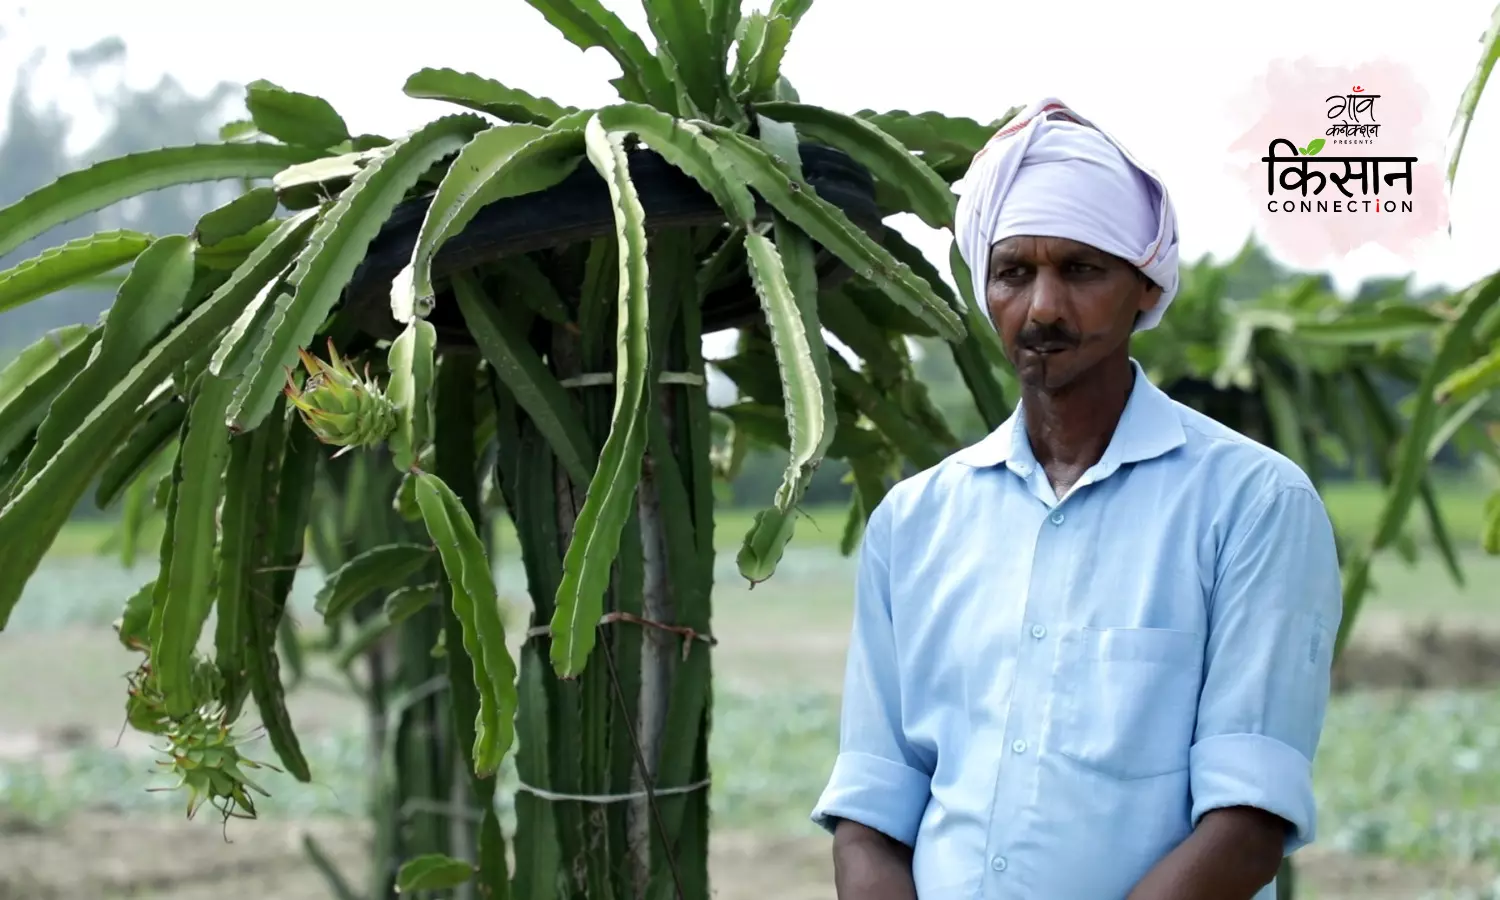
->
813 99 1341 900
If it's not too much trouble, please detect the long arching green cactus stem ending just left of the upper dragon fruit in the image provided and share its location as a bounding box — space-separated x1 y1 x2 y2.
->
230 114 486 431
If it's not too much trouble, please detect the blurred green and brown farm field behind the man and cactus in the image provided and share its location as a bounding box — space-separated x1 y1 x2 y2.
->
0 485 1500 900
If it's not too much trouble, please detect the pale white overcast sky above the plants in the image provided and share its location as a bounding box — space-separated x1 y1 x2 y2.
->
0 0 1500 303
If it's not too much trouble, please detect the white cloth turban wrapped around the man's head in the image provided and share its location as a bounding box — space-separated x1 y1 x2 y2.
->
954 98 1178 332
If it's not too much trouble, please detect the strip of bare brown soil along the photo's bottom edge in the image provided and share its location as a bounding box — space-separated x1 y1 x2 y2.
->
0 813 1494 900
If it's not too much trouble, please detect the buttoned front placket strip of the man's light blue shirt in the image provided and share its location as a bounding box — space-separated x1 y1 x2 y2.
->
984 477 1079 900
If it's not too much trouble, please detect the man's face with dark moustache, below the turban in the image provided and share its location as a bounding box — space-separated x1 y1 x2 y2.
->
984 236 1161 392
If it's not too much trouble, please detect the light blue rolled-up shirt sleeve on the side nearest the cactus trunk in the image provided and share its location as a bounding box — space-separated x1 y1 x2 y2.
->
812 503 932 846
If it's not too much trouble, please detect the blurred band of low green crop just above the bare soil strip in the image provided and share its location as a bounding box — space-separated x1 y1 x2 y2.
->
0 687 1500 863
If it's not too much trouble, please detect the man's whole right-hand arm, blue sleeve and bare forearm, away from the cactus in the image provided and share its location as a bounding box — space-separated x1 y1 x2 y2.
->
1128 485 1343 900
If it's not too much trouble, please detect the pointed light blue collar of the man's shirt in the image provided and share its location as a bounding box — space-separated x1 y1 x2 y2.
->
954 359 1187 482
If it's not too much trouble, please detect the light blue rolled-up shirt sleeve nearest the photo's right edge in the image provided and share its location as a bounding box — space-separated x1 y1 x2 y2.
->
1190 485 1343 855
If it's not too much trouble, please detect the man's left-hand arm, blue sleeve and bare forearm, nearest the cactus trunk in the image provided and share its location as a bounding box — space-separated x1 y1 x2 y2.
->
812 498 932 900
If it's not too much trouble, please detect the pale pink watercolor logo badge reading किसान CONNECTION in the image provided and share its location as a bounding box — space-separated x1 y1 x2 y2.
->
1230 60 1448 267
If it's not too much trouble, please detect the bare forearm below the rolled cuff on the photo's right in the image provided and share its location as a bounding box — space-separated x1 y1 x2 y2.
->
1127 807 1289 900
